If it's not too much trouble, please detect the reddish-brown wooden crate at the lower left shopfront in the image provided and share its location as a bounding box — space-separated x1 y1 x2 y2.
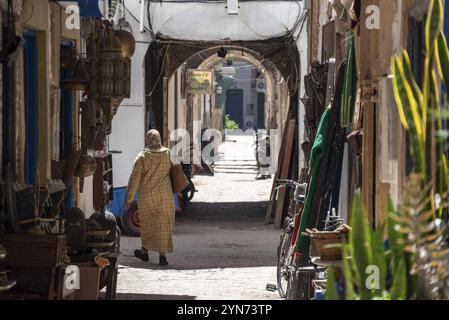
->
0 234 67 268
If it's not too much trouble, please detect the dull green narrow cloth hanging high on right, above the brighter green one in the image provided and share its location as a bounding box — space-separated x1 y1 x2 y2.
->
340 32 358 128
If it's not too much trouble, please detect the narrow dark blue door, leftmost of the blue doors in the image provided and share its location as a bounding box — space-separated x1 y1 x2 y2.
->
23 30 39 184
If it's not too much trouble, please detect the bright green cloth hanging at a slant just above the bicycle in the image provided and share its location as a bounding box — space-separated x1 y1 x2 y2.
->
296 107 331 252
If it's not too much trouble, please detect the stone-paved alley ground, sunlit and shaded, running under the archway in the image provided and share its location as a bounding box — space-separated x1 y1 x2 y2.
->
117 134 280 300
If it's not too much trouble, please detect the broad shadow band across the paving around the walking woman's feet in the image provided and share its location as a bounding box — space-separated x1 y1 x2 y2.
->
121 202 281 270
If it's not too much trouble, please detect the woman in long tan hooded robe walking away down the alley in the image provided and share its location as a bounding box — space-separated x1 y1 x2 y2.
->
126 130 175 266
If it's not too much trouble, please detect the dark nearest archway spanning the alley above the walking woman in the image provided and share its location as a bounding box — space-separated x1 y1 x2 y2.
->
145 36 301 139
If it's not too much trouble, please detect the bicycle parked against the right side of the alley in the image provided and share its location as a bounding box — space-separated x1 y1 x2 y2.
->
275 180 308 299
